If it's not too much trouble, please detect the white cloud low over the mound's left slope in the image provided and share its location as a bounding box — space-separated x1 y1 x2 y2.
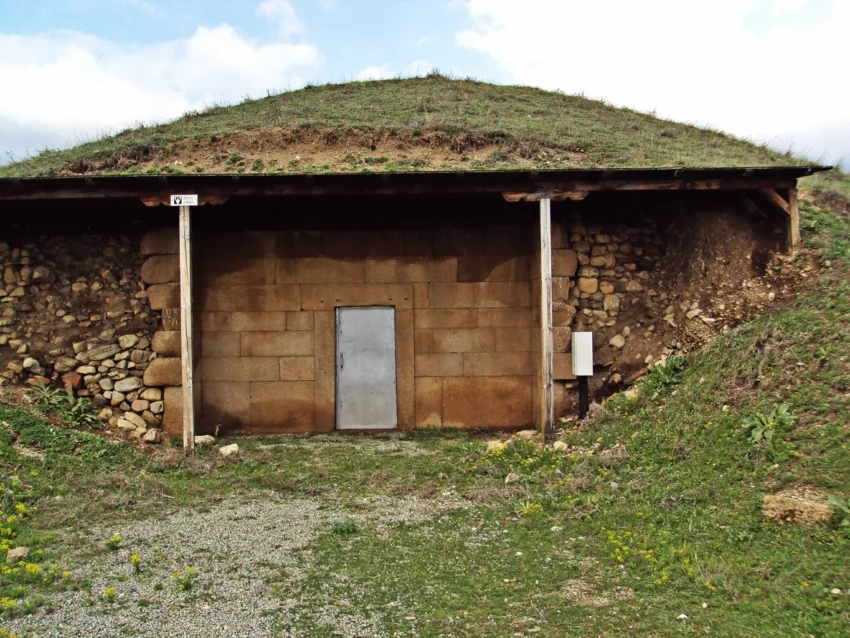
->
0 24 322 161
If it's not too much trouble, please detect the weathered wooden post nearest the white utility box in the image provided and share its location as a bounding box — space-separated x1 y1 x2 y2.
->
540 198 555 442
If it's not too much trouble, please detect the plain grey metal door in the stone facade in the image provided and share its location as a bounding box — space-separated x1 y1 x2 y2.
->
336 307 398 430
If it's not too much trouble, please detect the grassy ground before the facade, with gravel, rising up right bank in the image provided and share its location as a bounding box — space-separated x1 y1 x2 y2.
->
0 191 850 636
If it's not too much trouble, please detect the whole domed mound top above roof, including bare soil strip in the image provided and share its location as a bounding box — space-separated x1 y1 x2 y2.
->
0 74 810 177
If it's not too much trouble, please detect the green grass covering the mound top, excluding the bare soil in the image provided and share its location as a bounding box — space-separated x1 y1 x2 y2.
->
0 74 810 177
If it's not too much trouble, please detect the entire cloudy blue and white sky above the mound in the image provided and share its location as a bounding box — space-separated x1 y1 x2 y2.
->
0 0 850 163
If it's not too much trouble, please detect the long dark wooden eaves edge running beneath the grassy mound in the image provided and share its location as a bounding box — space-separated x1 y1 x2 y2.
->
0 166 828 205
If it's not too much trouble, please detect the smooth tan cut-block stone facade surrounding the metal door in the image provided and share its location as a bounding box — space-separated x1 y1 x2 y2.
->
142 226 534 433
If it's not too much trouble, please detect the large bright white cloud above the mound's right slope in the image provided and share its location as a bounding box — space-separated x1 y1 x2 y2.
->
457 0 850 161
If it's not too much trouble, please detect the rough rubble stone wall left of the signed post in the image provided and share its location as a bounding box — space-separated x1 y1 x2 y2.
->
0 235 164 442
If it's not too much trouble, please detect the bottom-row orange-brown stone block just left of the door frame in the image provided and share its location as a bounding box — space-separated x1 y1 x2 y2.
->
250 381 315 433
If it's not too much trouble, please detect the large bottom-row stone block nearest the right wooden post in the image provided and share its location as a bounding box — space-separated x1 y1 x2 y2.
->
443 377 534 428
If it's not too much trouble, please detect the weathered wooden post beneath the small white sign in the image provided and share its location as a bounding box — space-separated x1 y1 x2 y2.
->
180 206 195 455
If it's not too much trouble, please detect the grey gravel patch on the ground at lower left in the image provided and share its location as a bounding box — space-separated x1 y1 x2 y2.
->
7 494 460 638
